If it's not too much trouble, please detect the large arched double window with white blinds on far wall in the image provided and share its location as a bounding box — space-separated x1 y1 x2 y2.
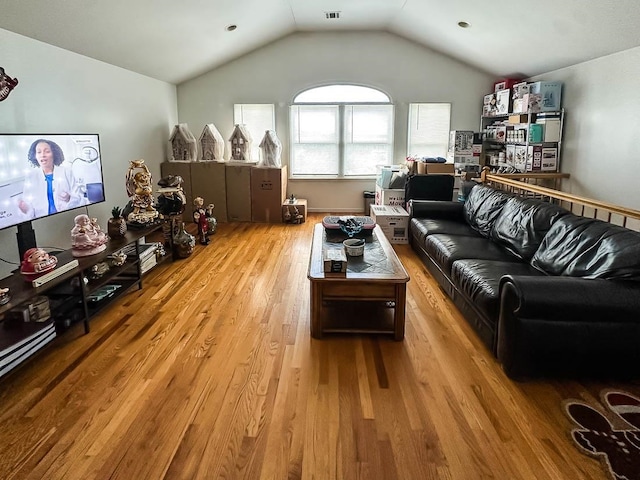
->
289 85 394 178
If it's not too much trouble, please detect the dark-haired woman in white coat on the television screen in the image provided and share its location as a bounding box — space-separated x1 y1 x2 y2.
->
18 139 85 219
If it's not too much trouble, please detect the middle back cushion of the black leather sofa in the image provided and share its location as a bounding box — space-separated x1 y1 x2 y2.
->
490 197 569 262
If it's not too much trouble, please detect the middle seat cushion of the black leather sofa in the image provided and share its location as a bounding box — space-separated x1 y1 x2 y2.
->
425 233 517 274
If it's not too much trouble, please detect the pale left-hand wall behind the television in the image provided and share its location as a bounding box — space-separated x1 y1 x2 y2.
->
0 29 178 278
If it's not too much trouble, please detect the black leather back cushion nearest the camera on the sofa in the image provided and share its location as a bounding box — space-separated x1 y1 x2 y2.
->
531 214 640 281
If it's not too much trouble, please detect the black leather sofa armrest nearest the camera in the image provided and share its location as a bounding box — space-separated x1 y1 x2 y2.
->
496 275 640 379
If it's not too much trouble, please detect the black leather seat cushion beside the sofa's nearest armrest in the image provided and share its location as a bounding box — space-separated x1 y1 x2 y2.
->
451 259 544 323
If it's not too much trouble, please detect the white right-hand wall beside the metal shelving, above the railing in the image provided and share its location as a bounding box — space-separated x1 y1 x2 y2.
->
534 47 640 210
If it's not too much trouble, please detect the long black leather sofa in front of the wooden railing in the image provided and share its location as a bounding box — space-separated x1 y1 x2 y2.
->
408 185 640 378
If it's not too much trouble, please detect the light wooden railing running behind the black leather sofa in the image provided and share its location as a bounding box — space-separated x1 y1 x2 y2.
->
480 169 640 231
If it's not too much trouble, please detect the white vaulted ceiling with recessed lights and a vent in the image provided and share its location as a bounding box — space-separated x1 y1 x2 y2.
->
0 0 640 84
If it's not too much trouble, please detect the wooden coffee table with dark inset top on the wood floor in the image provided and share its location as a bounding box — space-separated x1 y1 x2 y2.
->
307 223 409 340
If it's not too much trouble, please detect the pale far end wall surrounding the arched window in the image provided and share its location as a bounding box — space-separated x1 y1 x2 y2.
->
178 32 495 212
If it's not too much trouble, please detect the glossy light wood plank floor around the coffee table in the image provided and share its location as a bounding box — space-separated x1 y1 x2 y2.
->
0 214 640 480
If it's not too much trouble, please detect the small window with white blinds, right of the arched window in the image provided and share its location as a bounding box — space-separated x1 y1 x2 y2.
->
407 103 451 158
